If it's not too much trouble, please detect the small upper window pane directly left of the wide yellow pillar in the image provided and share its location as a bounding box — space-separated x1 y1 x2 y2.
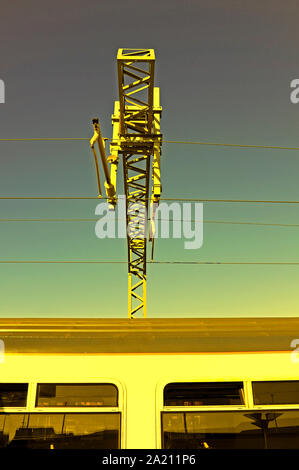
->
36 384 118 407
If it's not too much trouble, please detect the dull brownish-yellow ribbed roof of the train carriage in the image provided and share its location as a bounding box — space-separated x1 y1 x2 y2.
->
0 317 299 354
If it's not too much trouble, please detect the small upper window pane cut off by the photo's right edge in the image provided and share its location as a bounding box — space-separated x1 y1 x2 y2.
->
252 380 299 405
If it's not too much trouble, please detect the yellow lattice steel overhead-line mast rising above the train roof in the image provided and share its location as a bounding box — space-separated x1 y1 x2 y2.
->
114 49 161 318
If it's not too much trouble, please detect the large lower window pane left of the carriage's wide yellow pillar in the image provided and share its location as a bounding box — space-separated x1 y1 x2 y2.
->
0 413 120 449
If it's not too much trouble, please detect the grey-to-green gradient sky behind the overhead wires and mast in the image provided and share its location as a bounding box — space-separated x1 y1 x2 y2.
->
0 0 299 318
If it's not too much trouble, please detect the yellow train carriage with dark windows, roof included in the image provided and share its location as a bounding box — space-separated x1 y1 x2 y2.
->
0 318 299 449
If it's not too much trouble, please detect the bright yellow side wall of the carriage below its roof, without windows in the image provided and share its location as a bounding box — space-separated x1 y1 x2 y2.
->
1 350 298 449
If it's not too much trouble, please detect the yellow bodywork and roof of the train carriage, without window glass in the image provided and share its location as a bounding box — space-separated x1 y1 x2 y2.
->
0 317 299 449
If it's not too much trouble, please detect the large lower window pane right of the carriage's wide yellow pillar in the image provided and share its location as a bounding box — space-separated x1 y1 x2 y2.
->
162 410 299 449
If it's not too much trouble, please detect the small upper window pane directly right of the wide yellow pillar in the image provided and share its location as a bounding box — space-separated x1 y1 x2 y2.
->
164 382 244 406
